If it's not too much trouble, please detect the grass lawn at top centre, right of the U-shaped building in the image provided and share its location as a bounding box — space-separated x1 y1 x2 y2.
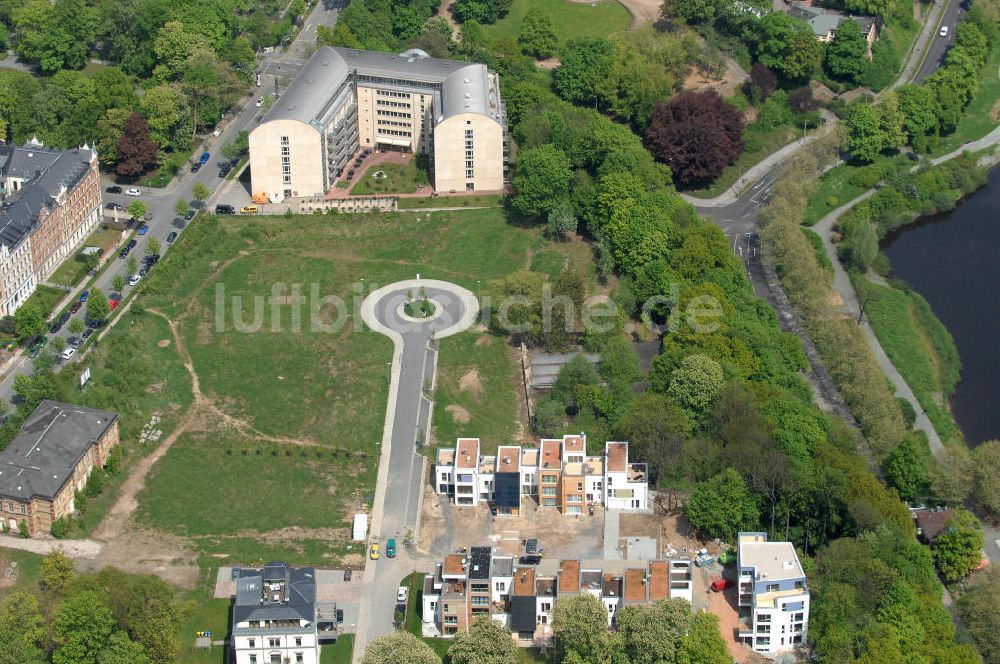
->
483 0 631 47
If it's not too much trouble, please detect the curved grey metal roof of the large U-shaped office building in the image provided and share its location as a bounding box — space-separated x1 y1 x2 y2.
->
261 46 491 124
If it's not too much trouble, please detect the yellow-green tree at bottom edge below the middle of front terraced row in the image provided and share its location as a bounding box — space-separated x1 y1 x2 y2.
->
552 593 610 662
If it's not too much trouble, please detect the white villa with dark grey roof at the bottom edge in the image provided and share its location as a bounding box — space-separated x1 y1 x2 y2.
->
230 562 337 664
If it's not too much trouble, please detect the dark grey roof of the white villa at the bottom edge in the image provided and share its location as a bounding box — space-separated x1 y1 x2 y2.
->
233 562 316 627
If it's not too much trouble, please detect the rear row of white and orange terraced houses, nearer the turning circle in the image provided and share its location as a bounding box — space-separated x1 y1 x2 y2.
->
432 434 648 516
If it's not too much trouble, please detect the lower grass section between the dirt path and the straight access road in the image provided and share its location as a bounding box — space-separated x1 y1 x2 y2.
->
137 432 376 564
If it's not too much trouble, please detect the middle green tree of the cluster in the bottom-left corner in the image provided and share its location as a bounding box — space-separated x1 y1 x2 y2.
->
52 590 115 664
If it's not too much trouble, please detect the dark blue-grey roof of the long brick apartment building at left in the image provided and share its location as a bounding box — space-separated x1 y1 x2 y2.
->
0 143 94 248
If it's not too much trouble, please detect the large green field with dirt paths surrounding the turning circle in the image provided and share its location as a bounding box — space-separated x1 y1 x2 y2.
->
123 208 545 566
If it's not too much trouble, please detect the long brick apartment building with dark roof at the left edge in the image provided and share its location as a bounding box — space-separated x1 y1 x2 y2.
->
0 139 101 315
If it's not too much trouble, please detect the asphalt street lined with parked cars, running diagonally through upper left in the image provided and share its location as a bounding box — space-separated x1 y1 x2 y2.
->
0 3 337 402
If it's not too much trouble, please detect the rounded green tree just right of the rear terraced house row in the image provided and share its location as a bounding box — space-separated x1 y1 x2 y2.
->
685 468 760 542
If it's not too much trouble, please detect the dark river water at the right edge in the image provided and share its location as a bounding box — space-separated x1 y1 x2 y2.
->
882 168 1000 446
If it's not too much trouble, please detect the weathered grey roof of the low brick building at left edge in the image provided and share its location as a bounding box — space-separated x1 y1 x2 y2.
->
0 400 118 500
